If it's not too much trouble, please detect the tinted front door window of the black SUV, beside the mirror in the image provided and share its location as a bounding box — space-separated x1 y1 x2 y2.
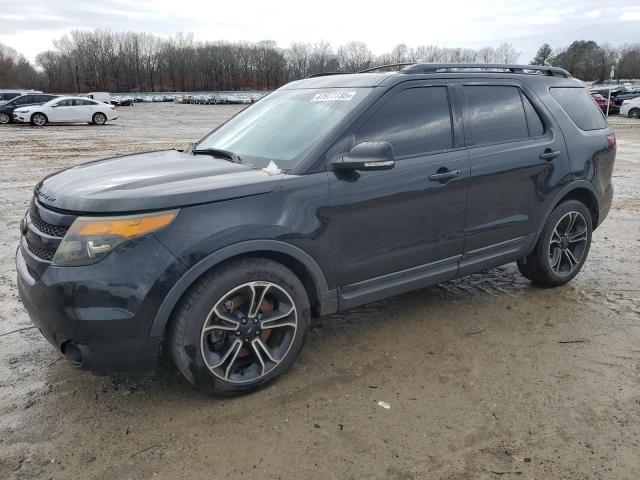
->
356 87 453 157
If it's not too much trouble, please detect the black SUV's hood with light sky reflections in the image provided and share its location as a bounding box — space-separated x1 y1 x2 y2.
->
34 150 284 213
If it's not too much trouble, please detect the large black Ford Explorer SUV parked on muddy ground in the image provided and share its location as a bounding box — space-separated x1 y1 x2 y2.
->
16 64 616 394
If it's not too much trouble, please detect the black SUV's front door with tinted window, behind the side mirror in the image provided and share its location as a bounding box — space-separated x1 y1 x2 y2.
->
329 82 469 308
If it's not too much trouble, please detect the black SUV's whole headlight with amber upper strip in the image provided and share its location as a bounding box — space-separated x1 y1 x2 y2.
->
52 210 179 267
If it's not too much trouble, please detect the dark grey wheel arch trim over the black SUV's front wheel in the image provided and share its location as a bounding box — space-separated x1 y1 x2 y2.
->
150 240 338 337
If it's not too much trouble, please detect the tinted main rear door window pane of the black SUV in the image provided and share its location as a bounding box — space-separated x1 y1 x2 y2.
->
463 85 529 145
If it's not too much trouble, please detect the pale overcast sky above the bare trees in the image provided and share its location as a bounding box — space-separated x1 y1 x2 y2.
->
0 0 640 63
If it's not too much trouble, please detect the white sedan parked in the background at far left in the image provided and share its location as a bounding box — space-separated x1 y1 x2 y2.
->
13 97 118 127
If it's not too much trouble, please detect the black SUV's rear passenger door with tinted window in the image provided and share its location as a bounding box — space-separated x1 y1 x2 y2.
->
458 81 570 274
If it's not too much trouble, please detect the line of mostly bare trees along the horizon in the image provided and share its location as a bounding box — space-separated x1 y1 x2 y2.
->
0 30 640 93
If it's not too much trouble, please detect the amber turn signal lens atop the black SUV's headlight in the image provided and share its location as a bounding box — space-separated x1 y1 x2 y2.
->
69 210 178 238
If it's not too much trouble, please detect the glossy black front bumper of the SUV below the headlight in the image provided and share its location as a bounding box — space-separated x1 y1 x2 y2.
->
16 235 184 373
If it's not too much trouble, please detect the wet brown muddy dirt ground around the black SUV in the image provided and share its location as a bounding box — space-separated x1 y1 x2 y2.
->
0 104 640 480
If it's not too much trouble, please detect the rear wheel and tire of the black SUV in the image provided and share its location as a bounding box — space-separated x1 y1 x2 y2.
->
517 200 593 287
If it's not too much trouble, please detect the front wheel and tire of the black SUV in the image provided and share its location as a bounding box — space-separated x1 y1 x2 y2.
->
168 258 310 396
